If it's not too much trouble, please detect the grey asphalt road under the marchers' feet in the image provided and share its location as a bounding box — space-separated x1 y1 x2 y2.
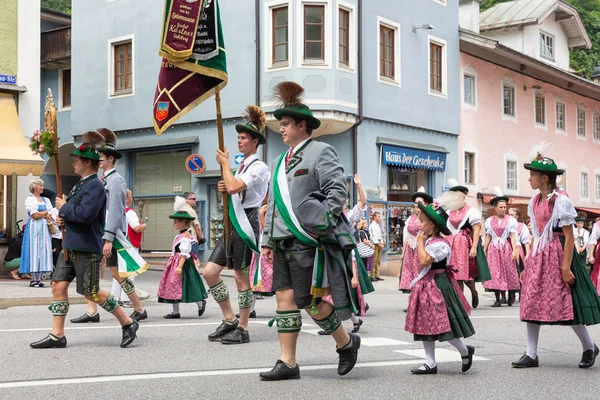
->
0 271 600 400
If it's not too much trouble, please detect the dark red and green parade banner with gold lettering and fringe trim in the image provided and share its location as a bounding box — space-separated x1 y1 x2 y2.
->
153 0 227 135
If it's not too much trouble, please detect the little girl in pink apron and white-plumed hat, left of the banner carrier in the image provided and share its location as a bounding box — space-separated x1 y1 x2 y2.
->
158 196 208 319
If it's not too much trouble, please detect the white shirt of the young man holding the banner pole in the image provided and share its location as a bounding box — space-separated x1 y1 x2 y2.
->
235 154 270 208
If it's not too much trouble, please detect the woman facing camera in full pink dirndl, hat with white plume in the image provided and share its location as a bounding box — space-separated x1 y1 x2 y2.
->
483 189 521 307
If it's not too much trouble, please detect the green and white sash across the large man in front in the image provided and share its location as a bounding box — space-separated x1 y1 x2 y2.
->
273 153 330 300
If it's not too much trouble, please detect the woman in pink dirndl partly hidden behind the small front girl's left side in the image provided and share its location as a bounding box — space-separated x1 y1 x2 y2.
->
400 187 433 293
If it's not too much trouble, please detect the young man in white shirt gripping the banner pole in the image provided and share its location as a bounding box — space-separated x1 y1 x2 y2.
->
204 106 269 344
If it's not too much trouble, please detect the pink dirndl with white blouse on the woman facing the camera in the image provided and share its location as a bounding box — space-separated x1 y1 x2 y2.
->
483 215 521 291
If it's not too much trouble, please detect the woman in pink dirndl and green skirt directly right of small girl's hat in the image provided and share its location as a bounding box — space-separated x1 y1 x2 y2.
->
440 179 491 308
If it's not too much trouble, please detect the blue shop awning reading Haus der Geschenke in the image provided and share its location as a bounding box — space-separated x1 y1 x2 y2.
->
377 138 448 171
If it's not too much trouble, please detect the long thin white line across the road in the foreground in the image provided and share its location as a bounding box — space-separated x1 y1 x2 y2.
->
0 359 482 389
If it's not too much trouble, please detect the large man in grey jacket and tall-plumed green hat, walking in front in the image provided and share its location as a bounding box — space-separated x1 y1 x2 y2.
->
260 82 360 381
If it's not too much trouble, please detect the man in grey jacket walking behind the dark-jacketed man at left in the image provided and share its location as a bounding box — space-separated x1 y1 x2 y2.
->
71 128 148 323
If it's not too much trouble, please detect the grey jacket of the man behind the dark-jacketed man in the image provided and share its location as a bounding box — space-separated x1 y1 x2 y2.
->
102 170 127 242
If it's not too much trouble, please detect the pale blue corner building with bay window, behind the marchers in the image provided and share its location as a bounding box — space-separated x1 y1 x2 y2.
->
70 0 460 257
